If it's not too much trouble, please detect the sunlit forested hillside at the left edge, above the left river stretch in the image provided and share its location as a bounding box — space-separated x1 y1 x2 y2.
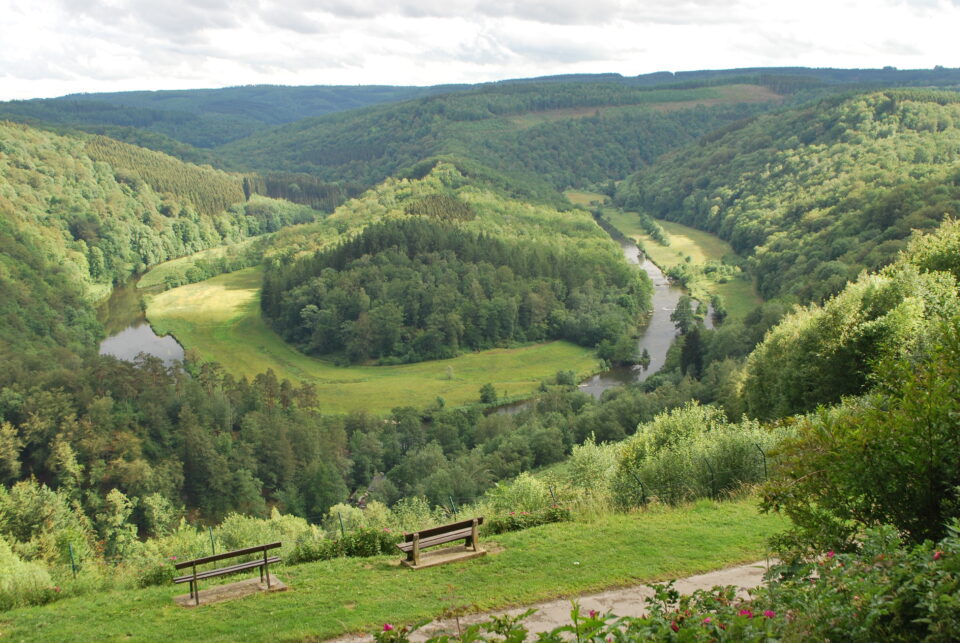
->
0 123 315 366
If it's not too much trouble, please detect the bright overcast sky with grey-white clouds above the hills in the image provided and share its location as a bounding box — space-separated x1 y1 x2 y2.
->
0 0 960 100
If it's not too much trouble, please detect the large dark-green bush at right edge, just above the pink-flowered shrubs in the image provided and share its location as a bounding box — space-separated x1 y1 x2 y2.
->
764 318 960 549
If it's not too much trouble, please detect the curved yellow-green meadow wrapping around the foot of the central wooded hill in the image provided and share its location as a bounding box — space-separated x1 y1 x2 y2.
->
147 268 598 413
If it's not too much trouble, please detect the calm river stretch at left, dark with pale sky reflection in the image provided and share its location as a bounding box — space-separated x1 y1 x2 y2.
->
97 278 183 366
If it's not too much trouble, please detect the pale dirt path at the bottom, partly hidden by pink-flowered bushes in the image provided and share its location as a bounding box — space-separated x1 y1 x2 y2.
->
331 561 767 643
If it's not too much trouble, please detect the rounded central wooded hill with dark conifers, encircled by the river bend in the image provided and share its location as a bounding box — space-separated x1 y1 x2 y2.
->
262 163 651 363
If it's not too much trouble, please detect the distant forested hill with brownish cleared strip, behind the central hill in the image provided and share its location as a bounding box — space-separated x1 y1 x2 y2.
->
218 82 781 196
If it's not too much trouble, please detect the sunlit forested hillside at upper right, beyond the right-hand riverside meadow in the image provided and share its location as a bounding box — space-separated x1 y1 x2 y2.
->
617 89 960 302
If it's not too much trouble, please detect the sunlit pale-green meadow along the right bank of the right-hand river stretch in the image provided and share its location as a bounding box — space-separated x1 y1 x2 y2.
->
604 208 762 319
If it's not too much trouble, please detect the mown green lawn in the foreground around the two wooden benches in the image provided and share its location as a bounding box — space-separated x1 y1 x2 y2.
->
0 498 785 641
